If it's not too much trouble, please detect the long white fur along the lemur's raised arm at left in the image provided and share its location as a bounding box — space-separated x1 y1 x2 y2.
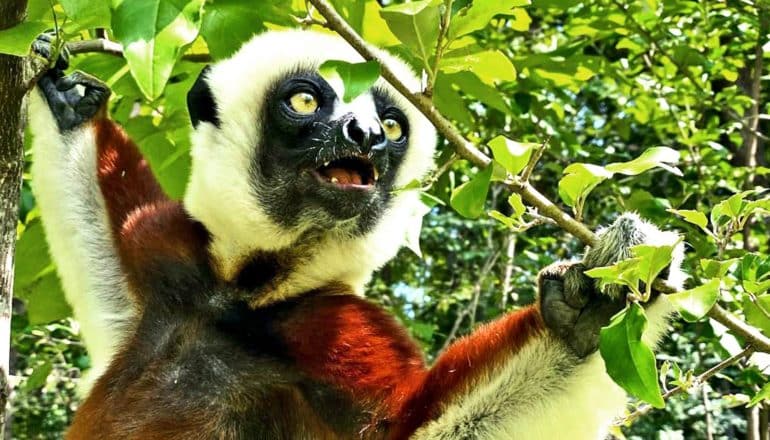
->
29 90 134 389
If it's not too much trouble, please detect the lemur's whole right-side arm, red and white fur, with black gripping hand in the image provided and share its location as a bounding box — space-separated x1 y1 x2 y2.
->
282 263 668 440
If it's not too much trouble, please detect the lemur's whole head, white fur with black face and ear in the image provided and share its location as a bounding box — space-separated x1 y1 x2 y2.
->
185 31 436 292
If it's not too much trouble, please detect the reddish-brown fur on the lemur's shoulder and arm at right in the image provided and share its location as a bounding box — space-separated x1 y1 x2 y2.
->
283 295 544 439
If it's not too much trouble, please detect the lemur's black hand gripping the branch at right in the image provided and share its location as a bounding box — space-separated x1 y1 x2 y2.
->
538 262 626 358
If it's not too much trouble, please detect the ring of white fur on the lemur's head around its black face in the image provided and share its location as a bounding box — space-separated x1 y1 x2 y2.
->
180 30 436 296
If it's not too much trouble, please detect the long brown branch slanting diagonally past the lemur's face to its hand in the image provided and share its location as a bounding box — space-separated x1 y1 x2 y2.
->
308 0 770 353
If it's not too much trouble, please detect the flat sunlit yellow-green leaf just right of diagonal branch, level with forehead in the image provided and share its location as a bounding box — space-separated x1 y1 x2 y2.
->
439 50 516 87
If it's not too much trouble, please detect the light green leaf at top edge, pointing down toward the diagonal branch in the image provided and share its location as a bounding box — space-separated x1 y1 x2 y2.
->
380 0 441 66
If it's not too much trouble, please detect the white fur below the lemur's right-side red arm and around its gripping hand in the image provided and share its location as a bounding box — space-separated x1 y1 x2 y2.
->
413 214 685 440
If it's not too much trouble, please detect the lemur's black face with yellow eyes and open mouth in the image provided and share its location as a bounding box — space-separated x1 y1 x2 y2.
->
252 72 409 233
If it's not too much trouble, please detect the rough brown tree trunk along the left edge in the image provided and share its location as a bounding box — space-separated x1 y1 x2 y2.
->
0 0 27 437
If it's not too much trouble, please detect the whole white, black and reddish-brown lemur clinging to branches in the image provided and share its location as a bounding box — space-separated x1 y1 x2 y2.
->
30 31 681 440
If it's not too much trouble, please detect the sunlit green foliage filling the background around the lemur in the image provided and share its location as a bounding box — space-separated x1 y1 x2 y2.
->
6 0 770 438
